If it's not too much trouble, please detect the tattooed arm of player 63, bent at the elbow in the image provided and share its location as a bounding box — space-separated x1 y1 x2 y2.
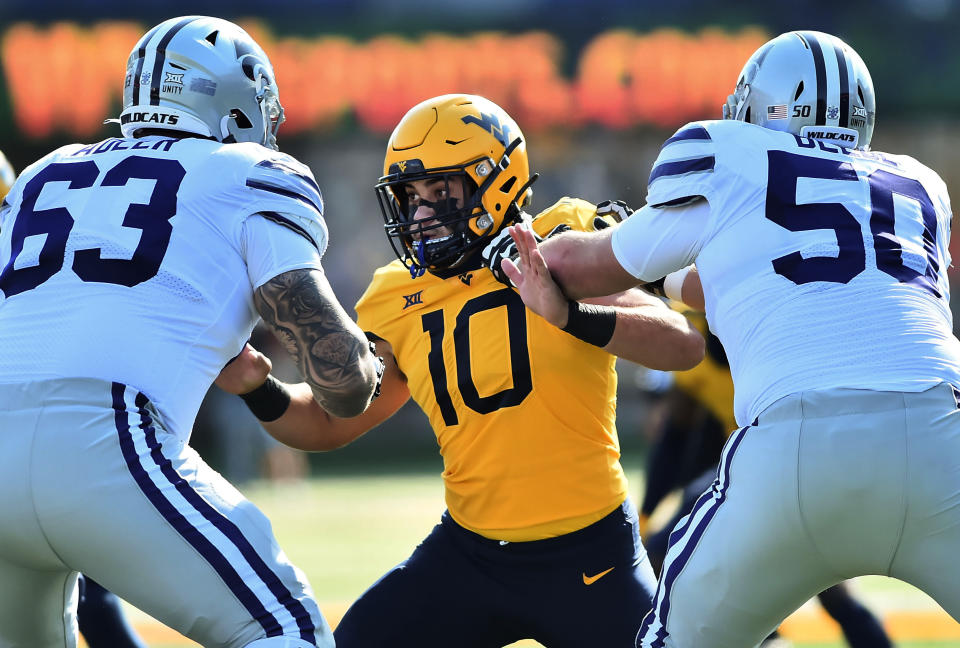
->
254 269 380 417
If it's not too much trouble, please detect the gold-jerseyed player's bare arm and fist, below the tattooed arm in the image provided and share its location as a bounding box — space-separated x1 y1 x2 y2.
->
216 340 410 451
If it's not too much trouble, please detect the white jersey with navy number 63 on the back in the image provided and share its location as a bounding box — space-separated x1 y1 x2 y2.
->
0 136 327 438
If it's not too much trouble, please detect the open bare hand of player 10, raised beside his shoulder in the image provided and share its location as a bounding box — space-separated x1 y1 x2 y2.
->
503 225 568 328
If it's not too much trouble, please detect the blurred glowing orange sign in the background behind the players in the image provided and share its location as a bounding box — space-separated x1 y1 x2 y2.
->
0 22 767 137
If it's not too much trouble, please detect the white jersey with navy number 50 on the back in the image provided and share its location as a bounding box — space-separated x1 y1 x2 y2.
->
613 121 960 425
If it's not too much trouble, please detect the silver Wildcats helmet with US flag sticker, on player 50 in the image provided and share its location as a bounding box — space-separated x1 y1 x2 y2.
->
723 31 876 150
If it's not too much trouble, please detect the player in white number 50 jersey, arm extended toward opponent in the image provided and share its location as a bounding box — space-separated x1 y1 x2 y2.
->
491 31 960 648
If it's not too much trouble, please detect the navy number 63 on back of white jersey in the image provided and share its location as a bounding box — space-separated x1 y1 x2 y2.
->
0 155 186 298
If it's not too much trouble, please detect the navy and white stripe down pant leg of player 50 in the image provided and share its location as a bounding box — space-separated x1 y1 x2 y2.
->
637 426 751 648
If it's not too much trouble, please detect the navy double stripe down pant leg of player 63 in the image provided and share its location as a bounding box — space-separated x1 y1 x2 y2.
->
113 383 316 645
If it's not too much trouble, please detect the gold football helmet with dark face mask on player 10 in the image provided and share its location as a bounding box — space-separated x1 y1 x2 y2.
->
376 94 537 276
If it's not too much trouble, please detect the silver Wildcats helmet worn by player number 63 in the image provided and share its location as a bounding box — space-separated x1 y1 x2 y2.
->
120 16 284 149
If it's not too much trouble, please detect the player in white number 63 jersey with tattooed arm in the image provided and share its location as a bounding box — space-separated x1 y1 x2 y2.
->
0 16 382 648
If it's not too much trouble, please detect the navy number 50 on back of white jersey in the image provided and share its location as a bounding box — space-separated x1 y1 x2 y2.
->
766 151 940 298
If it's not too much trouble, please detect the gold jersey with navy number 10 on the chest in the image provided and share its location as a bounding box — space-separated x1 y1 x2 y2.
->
356 198 627 542
